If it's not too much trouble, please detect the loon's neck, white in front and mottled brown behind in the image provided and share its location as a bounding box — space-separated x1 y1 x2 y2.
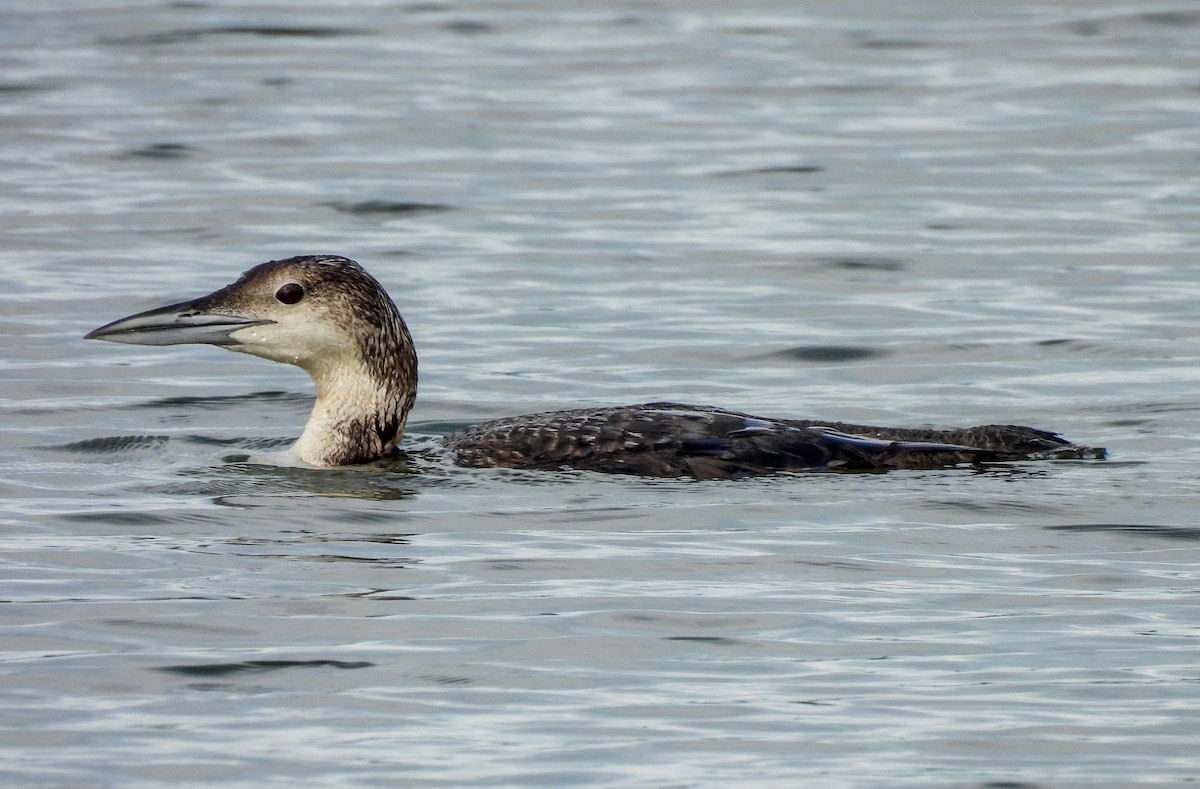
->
292 350 416 466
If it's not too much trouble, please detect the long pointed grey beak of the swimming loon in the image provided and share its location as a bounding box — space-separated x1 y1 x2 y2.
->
84 296 275 345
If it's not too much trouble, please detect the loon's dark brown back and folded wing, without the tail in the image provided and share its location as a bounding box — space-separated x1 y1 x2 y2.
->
443 403 1010 480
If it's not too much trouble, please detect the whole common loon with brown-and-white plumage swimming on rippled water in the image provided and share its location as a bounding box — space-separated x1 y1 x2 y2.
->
86 255 1104 478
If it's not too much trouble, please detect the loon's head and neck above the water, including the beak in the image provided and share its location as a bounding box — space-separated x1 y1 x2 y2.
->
85 255 416 466
